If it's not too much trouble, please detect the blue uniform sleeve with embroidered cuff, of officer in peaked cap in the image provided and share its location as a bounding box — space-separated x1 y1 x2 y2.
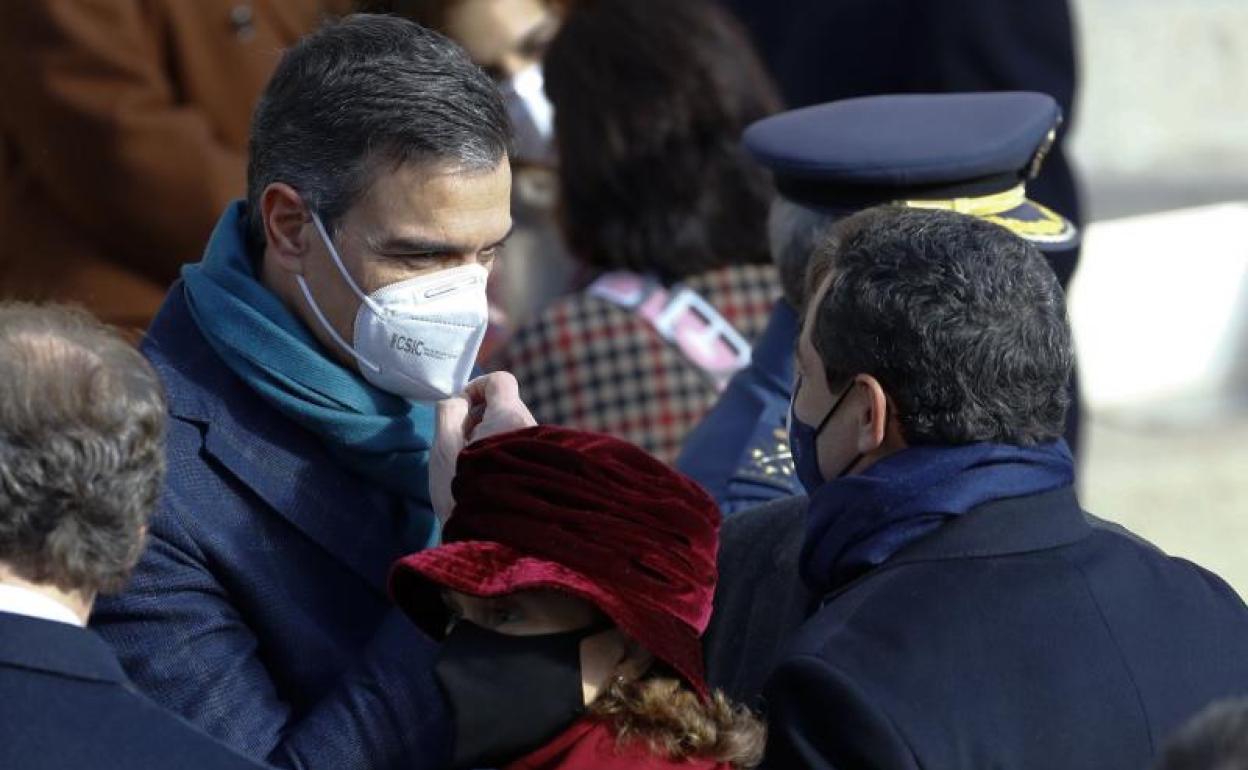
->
675 300 804 514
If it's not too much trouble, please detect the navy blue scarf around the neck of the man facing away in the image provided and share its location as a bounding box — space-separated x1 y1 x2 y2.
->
801 439 1075 594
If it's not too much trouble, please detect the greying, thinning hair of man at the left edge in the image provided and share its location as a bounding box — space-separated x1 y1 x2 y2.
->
0 302 165 592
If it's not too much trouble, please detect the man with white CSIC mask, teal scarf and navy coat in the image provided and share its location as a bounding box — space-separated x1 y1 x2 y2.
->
94 16 512 769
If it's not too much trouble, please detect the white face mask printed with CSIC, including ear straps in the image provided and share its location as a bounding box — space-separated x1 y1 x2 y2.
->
297 213 489 401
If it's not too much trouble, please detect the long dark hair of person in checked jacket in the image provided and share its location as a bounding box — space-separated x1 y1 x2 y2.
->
544 0 779 283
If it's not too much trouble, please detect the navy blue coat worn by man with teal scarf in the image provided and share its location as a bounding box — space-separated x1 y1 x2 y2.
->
92 283 451 770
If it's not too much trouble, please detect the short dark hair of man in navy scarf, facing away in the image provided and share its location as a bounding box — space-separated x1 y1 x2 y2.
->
811 207 1072 446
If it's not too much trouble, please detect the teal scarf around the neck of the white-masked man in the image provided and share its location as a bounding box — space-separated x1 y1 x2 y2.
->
182 201 437 542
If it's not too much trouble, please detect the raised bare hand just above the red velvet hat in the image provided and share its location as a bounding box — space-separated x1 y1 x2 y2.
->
429 372 538 522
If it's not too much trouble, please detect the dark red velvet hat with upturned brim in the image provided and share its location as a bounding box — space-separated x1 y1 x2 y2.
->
389 426 720 696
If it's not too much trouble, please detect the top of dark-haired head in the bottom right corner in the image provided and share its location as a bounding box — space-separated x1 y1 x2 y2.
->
1156 698 1248 770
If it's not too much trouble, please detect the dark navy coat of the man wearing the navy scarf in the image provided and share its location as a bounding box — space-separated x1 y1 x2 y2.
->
764 488 1248 770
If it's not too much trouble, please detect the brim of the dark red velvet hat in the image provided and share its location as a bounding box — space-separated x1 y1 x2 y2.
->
389 540 708 698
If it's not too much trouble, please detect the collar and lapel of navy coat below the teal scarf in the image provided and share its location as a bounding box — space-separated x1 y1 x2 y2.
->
142 282 411 593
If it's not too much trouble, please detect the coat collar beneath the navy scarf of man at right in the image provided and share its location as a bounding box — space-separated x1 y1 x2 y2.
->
824 487 1093 604
